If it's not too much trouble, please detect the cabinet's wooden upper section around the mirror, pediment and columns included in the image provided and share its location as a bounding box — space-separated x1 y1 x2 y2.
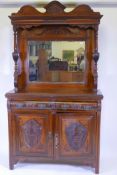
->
10 1 102 92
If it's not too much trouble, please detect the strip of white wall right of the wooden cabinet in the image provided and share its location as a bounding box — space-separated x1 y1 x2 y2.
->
95 8 117 156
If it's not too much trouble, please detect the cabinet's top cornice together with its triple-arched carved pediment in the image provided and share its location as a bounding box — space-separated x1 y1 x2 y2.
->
10 1 102 29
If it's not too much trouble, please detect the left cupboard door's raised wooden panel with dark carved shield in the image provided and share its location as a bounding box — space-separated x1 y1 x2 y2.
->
15 112 53 157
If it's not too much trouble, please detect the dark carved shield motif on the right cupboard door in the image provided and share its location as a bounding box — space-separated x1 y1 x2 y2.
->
65 122 87 151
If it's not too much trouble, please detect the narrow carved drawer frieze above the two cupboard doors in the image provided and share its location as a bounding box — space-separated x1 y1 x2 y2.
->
8 101 100 110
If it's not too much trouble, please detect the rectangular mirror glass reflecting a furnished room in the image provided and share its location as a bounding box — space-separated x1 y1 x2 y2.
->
28 41 86 82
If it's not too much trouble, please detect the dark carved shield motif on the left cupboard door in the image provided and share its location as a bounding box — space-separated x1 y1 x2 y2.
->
22 120 42 148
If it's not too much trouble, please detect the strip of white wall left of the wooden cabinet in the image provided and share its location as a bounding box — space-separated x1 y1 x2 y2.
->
0 8 15 157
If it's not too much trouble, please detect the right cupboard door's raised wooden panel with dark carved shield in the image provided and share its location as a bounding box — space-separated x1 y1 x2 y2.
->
55 112 96 159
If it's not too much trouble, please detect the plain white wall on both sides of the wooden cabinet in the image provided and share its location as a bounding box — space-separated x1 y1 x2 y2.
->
0 2 117 170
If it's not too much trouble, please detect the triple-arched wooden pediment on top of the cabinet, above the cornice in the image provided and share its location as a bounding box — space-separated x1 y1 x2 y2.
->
12 1 101 18
